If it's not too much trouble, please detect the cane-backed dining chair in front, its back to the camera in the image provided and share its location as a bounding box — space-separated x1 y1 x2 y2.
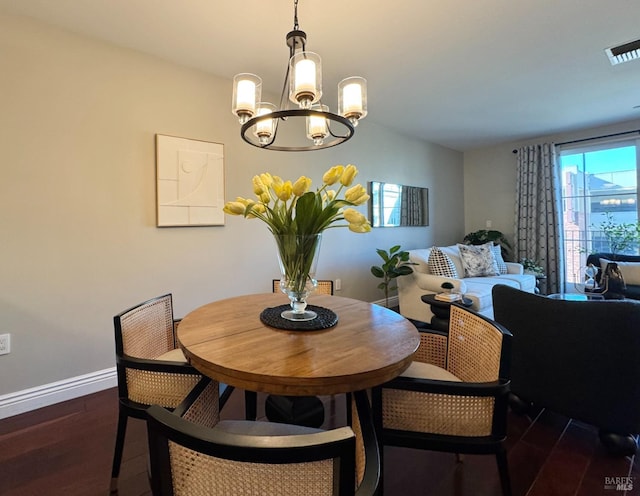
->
147 379 380 496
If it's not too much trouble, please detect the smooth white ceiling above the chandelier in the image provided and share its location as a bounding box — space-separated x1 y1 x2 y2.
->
0 0 640 151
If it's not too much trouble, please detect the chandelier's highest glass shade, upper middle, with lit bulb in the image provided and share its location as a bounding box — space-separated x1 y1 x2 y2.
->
289 52 322 109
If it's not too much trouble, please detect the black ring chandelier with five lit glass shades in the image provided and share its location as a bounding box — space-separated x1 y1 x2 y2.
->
232 0 367 151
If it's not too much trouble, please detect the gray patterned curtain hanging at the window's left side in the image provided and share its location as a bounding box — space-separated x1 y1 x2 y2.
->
515 143 564 293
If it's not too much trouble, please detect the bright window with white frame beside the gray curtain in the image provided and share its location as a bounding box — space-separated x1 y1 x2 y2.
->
559 139 640 283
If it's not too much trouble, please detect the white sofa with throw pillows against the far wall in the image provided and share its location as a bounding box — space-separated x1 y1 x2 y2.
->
397 245 536 322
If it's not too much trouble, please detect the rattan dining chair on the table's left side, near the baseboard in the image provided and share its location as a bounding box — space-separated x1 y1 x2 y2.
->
111 294 233 492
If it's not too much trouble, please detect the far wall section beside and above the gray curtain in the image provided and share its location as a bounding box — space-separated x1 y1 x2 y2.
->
464 119 640 254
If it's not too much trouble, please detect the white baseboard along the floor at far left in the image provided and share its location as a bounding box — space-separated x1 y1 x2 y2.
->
0 367 118 419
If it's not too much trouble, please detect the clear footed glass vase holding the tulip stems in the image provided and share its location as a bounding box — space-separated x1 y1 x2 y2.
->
274 234 322 321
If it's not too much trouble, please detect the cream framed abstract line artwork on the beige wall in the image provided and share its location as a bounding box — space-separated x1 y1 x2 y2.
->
156 134 224 227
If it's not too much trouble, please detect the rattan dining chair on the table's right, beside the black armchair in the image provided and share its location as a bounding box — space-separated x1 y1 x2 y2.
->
372 304 511 496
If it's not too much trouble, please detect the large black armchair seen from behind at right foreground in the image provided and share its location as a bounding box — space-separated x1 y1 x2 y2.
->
493 285 640 455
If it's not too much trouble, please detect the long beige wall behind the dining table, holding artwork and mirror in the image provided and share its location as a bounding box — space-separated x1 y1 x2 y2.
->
0 15 464 395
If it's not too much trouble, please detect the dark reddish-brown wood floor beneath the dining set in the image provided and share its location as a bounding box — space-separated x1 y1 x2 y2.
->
0 389 640 496
